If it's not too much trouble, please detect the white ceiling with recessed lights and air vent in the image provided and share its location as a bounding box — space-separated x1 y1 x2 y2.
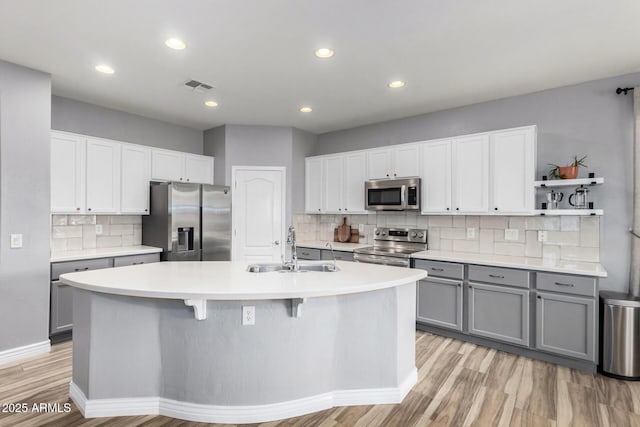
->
0 0 640 133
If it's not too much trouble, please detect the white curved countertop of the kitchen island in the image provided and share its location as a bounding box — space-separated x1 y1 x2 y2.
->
60 261 427 300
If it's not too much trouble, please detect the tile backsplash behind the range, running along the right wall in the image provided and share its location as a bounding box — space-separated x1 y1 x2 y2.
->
293 212 600 262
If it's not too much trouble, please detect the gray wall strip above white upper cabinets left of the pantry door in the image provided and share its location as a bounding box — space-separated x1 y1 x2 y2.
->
51 96 202 154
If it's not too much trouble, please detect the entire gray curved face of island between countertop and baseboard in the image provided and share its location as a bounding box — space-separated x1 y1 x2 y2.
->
74 283 415 406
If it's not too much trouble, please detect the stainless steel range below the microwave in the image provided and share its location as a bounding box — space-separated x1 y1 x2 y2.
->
353 227 427 267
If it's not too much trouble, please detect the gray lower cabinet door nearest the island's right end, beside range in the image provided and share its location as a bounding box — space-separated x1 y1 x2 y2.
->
416 277 463 331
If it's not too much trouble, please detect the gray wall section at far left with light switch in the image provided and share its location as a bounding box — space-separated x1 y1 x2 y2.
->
0 60 51 351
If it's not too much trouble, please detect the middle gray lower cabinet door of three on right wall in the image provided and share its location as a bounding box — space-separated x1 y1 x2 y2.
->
468 282 529 346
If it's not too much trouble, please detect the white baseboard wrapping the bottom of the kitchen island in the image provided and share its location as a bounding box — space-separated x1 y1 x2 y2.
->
69 369 418 424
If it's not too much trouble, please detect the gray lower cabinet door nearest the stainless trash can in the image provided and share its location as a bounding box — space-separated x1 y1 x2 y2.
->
536 290 597 361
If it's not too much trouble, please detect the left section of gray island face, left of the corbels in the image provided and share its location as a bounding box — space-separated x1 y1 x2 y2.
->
73 289 162 399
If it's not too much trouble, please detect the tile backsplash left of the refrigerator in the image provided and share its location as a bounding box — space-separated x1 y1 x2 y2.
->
51 215 142 252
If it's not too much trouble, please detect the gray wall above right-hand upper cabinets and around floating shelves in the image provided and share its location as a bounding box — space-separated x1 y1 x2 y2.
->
314 74 640 291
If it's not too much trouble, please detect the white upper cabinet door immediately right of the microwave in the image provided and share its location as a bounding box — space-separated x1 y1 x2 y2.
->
419 140 451 213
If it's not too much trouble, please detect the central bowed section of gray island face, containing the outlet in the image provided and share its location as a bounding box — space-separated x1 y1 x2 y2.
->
161 297 339 406
